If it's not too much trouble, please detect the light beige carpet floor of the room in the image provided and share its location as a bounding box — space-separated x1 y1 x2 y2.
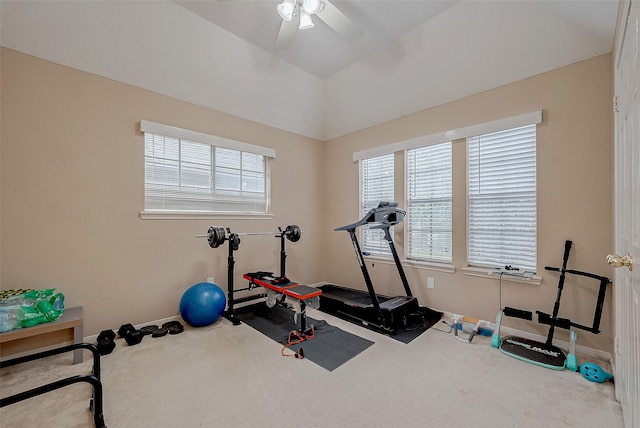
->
0 310 623 428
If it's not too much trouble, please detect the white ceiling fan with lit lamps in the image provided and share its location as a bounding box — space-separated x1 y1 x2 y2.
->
276 0 362 50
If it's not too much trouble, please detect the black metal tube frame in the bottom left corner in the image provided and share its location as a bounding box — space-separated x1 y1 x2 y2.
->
0 343 106 428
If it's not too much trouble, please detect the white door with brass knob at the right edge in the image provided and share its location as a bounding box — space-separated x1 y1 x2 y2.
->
613 0 640 428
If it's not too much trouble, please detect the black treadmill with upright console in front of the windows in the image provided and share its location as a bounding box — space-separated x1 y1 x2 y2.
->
320 201 421 334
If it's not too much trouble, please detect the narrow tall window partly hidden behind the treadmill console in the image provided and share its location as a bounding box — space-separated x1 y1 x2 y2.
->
360 153 394 256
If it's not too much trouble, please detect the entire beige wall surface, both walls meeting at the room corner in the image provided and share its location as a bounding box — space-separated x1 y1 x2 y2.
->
0 48 613 351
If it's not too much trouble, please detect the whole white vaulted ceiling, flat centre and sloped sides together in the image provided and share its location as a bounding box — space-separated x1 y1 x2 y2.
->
0 0 618 140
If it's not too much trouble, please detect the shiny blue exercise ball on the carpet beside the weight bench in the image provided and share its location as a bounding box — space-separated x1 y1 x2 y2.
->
180 282 227 327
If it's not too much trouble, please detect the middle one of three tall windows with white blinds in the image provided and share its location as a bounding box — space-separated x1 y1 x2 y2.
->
407 142 452 263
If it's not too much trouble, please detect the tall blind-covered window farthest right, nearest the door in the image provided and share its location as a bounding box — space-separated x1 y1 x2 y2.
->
468 125 537 271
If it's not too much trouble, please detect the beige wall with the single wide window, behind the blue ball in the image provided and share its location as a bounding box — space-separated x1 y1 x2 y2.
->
1 48 323 334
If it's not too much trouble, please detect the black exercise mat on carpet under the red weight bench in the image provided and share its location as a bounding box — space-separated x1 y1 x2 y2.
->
236 304 374 371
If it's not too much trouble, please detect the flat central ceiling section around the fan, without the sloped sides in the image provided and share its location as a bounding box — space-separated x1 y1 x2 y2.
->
176 0 458 79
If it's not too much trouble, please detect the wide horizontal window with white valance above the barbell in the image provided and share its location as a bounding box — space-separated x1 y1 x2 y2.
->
141 121 275 214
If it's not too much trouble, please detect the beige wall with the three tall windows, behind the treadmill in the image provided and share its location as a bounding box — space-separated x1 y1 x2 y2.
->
323 55 613 351
